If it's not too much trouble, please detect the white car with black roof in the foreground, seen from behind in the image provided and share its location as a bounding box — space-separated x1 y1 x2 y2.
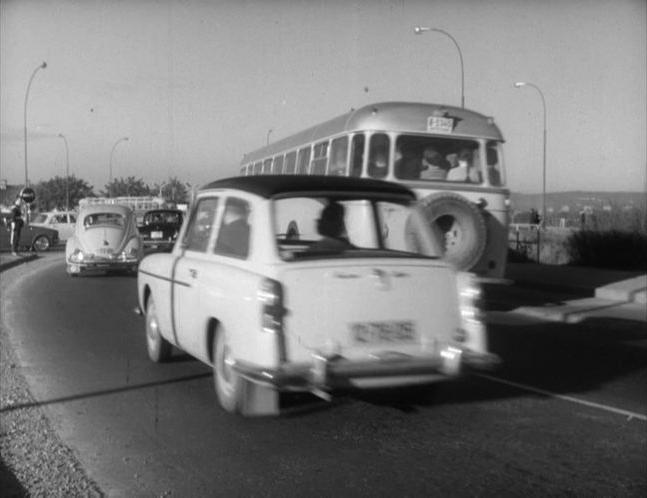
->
137 175 497 415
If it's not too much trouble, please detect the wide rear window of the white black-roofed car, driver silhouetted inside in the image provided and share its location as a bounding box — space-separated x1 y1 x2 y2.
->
274 196 442 260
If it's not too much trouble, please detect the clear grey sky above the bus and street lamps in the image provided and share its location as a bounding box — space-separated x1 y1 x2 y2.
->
0 0 647 193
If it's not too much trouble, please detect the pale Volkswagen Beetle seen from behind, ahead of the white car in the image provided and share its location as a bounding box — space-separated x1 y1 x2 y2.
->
65 204 144 276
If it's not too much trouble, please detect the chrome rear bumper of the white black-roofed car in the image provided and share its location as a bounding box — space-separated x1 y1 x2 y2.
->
234 346 500 392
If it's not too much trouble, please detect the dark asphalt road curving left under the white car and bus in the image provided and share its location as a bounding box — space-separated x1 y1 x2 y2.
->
3 259 647 496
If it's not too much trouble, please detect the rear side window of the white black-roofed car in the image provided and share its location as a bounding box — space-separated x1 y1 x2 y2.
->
214 197 250 259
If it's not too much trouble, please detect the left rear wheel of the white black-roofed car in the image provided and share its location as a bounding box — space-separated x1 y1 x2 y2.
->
213 326 244 413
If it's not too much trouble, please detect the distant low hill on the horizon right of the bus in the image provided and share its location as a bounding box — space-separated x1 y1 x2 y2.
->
510 190 647 213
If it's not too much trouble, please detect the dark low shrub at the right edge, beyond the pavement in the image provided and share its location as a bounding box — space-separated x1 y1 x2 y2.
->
565 230 647 270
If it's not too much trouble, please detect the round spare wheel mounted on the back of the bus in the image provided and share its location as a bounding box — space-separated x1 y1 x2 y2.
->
420 192 487 270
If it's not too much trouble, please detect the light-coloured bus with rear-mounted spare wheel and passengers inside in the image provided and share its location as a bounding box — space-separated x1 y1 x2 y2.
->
240 102 510 280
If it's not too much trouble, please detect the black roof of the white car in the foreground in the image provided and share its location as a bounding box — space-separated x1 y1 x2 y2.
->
200 175 415 199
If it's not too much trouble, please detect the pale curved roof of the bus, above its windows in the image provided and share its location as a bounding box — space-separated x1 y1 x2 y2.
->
242 102 503 163
